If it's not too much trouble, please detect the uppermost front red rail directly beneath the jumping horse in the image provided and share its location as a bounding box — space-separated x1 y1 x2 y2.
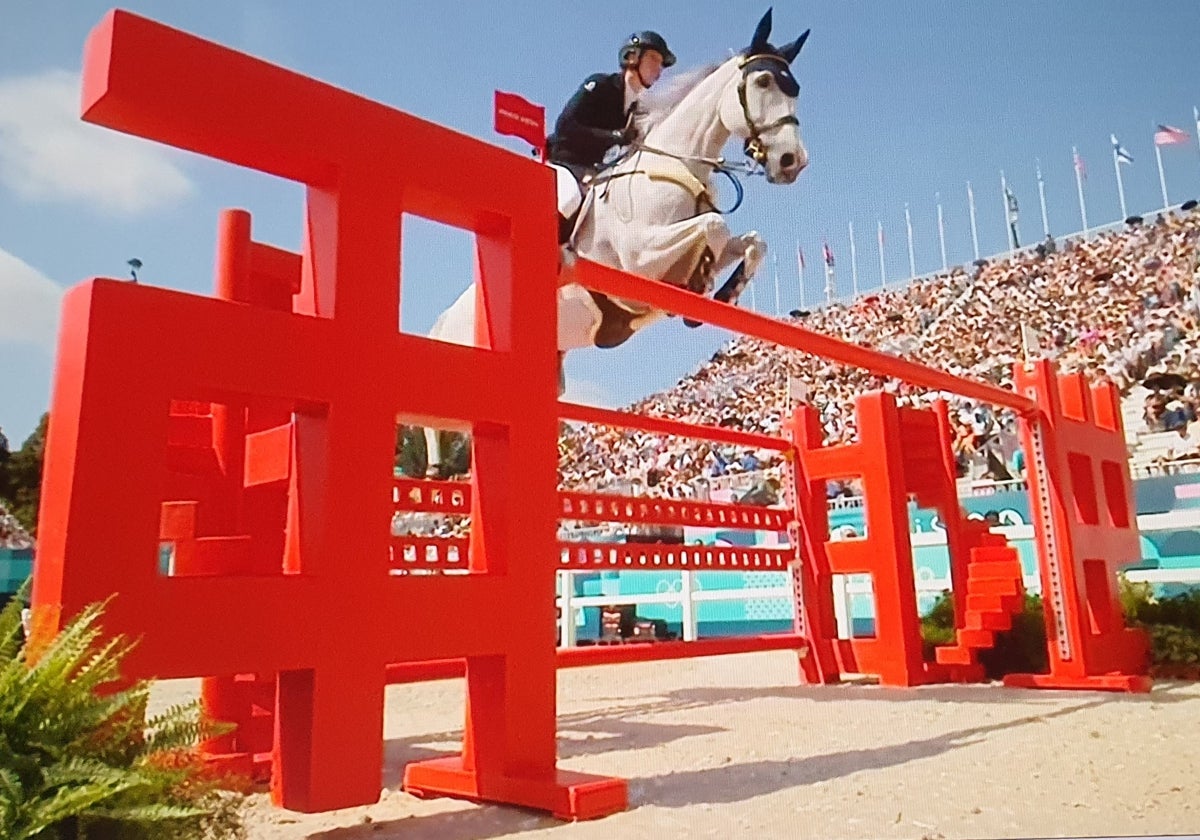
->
562 259 1037 414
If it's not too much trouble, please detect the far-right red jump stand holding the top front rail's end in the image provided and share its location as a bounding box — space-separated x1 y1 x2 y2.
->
1004 360 1151 691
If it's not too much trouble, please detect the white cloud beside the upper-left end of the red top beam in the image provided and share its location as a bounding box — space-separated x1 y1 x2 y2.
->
0 70 192 215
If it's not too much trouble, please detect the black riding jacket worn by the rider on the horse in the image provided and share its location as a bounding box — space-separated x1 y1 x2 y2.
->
547 73 628 166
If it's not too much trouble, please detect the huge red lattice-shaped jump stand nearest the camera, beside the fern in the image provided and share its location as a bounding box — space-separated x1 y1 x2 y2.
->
34 11 626 817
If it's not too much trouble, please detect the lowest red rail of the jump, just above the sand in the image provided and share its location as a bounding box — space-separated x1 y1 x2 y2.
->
386 634 809 685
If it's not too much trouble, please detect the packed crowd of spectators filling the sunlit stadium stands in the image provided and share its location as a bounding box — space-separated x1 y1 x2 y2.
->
559 205 1200 497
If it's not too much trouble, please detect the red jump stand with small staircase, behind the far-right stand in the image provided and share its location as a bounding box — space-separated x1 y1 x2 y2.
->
793 392 1024 685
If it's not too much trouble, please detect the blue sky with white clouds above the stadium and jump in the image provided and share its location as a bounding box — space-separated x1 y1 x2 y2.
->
0 0 1200 444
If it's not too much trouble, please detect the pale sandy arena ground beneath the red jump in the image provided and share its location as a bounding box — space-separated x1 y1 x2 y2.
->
156 653 1200 840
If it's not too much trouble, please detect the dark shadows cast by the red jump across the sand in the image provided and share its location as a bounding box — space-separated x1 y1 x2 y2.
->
310 682 1200 840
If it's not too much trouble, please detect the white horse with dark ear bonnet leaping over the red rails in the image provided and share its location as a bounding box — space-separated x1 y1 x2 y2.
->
425 10 809 475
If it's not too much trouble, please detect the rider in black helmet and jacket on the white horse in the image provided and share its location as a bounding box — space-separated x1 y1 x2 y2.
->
546 30 676 239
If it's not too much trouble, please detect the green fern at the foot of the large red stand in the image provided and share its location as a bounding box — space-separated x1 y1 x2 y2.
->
0 583 244 840
